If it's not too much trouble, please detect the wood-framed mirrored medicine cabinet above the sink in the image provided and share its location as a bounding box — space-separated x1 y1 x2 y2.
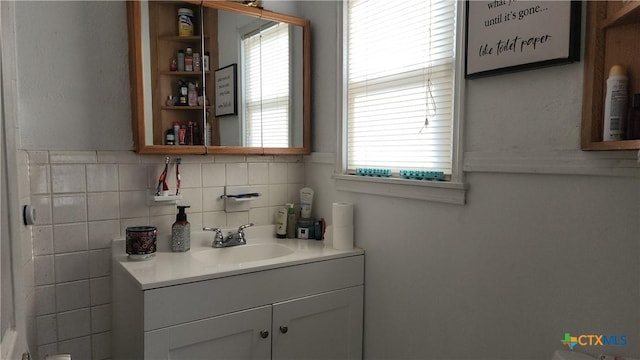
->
128 1 310 154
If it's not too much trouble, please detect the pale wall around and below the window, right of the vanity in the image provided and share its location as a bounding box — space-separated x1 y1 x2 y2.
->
303 2 640 359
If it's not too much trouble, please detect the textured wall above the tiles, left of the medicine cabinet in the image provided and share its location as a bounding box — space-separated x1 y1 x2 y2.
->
16 1 133 150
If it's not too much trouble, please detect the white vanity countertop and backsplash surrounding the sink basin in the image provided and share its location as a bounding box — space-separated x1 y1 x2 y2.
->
113 225 364 290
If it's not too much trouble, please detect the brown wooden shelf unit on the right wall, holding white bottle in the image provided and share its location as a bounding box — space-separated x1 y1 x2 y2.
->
581 0 640 150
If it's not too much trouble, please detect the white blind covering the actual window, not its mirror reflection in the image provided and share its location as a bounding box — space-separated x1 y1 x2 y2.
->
347 0 457 175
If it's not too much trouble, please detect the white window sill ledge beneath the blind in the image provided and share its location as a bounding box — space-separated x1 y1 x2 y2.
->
333 174 467 205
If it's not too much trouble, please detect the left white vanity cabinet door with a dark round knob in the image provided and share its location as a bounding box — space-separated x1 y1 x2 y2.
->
144 306 271 360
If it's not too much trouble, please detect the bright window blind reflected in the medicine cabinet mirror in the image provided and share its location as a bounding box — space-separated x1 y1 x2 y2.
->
243 23 290 147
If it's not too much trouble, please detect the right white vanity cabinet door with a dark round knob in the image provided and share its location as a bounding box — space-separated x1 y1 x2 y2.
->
272 286 363 360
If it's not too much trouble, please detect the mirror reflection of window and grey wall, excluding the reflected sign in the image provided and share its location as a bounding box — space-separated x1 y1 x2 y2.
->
218 11 304 148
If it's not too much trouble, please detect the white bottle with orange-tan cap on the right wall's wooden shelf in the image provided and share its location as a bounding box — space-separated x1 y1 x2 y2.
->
602 65 629 141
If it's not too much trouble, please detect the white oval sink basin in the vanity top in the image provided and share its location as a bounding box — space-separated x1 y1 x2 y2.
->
191 243 293 266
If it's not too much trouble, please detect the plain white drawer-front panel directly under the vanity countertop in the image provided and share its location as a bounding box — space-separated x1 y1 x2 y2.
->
144 255 364 331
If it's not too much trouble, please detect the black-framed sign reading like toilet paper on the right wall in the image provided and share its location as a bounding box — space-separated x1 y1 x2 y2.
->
465 0 581 78
